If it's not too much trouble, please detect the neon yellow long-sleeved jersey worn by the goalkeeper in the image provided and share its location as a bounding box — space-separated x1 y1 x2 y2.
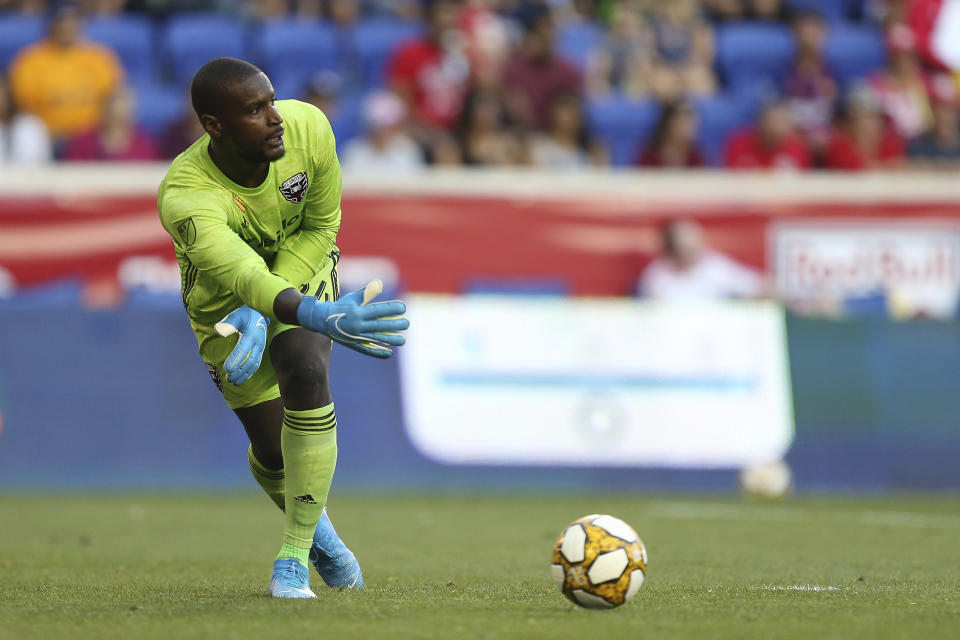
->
157 100 341 331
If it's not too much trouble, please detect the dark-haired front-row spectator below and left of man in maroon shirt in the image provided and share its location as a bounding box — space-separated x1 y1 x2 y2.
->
460 88 527 166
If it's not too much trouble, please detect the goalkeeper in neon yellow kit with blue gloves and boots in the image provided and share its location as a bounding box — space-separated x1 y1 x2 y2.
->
157 58 408 598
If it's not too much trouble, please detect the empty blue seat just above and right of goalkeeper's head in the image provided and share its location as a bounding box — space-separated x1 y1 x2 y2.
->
254 20 337 85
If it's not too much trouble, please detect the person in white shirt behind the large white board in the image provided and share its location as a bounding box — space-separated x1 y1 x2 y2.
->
638 221 768 300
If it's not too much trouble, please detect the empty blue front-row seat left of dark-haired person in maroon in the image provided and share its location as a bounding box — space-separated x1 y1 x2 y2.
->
587 95 660 167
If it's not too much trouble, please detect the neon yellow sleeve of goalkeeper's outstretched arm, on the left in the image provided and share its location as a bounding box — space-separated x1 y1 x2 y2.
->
161 192 293 320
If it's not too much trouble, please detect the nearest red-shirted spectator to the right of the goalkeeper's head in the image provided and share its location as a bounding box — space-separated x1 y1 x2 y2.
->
388 0 470 132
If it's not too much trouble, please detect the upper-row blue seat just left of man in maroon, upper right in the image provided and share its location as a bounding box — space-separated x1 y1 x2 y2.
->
717 22 796 87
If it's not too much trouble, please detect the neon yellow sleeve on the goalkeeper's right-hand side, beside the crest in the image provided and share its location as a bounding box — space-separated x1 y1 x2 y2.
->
272 109 342 283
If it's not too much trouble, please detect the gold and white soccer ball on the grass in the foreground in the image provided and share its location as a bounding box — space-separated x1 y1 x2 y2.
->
552 513 647 609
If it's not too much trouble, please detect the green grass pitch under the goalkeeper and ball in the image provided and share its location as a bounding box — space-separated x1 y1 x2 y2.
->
0 494 960 640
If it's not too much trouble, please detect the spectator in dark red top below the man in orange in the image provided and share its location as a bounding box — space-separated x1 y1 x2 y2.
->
64 87 160 162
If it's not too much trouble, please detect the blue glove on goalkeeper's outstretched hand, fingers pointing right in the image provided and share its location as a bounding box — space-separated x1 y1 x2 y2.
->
297 280 410 358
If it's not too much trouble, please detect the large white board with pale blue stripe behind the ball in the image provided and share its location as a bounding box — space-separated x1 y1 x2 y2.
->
401 295 794 469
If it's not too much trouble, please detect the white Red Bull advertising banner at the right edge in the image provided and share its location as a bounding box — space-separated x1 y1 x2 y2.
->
771 221 960 317
